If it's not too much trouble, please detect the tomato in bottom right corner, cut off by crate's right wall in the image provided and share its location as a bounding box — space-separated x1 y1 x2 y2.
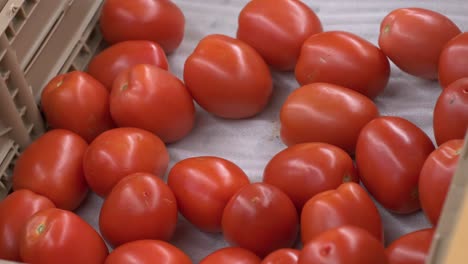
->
385 228 434 264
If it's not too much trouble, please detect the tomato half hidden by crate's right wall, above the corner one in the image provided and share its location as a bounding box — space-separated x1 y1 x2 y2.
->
419 139 463 225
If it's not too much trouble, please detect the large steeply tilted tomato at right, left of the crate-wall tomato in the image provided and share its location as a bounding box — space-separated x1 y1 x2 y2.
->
356 116 434 214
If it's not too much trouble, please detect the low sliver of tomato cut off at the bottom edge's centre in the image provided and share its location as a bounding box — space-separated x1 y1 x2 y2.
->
200 247 261 264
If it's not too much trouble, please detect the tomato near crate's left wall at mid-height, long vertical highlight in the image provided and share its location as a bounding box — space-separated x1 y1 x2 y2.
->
13 129 88 210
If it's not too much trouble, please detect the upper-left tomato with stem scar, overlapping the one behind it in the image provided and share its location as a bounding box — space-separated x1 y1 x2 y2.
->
110 64 195 143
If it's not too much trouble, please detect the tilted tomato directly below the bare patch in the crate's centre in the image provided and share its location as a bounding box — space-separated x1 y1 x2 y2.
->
167 156 250 232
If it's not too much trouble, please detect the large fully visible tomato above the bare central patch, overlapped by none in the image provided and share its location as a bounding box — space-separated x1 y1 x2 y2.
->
184 35 273 119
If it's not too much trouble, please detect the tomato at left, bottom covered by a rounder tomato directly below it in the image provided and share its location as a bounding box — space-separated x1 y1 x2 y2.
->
83 127 169 196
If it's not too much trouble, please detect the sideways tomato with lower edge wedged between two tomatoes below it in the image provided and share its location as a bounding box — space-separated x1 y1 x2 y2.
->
263 143 359 212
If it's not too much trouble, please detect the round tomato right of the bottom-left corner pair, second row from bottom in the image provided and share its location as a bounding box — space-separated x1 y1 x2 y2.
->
99 173 177 246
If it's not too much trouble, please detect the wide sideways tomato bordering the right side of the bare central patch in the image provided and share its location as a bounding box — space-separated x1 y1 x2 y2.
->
280 83 379 153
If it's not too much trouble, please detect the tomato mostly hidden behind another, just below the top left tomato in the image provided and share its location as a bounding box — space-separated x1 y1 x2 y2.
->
88 40 169 91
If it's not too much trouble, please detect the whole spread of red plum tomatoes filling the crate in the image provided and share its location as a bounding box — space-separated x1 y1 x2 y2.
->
0 0 468 264
